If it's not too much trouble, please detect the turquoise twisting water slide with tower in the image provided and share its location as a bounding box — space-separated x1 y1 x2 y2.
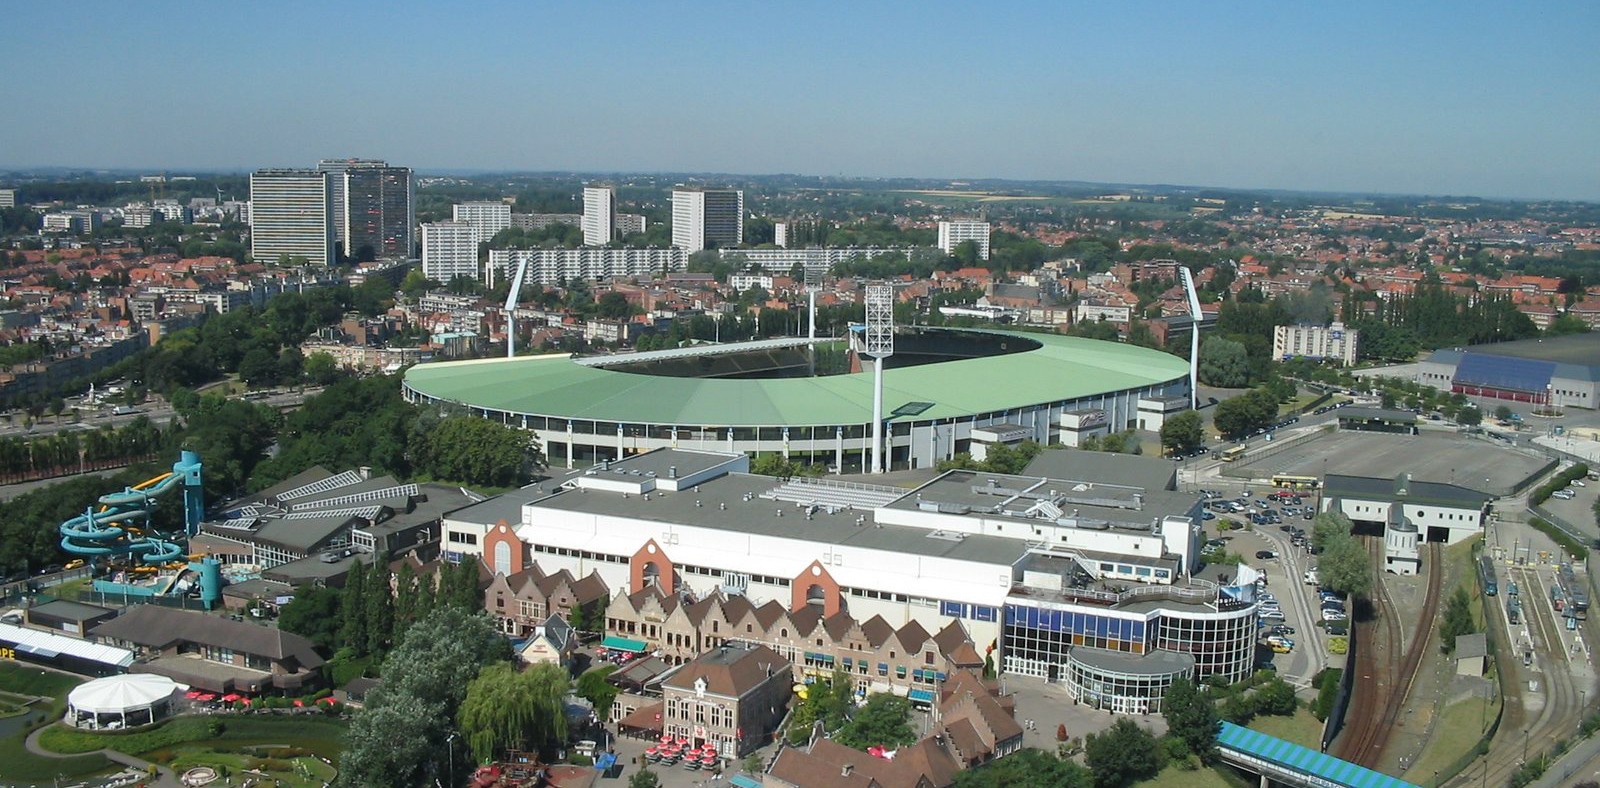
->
61 452 205 565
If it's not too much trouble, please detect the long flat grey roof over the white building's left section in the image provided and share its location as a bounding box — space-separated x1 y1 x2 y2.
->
534 474 1027 565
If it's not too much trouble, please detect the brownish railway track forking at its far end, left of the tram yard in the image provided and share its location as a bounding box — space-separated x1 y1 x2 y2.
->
1338 537 1443 769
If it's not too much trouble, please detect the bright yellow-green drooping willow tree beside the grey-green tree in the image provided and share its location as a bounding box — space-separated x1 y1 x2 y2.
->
459 663 566 764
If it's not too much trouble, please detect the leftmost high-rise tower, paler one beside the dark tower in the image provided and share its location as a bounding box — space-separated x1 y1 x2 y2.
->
250 170 334 266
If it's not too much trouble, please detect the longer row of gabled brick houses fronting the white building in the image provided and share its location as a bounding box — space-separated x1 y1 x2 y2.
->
606 586 984 702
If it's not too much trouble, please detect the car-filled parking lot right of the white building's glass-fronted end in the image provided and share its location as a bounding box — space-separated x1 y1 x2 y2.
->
1203 495 1342 687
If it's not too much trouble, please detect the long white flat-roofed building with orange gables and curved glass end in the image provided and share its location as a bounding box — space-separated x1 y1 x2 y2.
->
443 448 1256 711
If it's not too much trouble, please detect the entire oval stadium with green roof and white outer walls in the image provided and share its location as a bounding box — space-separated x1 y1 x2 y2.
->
403 328 1189 472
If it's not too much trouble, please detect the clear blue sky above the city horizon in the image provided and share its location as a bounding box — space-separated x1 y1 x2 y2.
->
0 0 1600 200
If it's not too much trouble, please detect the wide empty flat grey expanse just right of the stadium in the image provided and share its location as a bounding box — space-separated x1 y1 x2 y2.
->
1245 432 1547 495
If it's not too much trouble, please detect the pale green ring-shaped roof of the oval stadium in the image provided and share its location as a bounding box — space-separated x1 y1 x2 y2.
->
405 333 1189 426
